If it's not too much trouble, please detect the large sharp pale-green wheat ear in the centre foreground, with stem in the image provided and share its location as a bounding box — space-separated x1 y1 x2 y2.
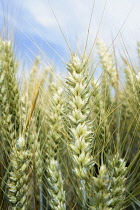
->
66 55 94 209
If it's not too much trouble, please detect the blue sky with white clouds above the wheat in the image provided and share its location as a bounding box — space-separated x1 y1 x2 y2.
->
0 0 140 73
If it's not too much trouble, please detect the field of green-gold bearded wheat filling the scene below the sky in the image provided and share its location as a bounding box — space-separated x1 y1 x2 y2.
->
0 0 140 210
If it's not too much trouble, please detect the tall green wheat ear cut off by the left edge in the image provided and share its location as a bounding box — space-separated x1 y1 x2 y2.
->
0 39 20 208
